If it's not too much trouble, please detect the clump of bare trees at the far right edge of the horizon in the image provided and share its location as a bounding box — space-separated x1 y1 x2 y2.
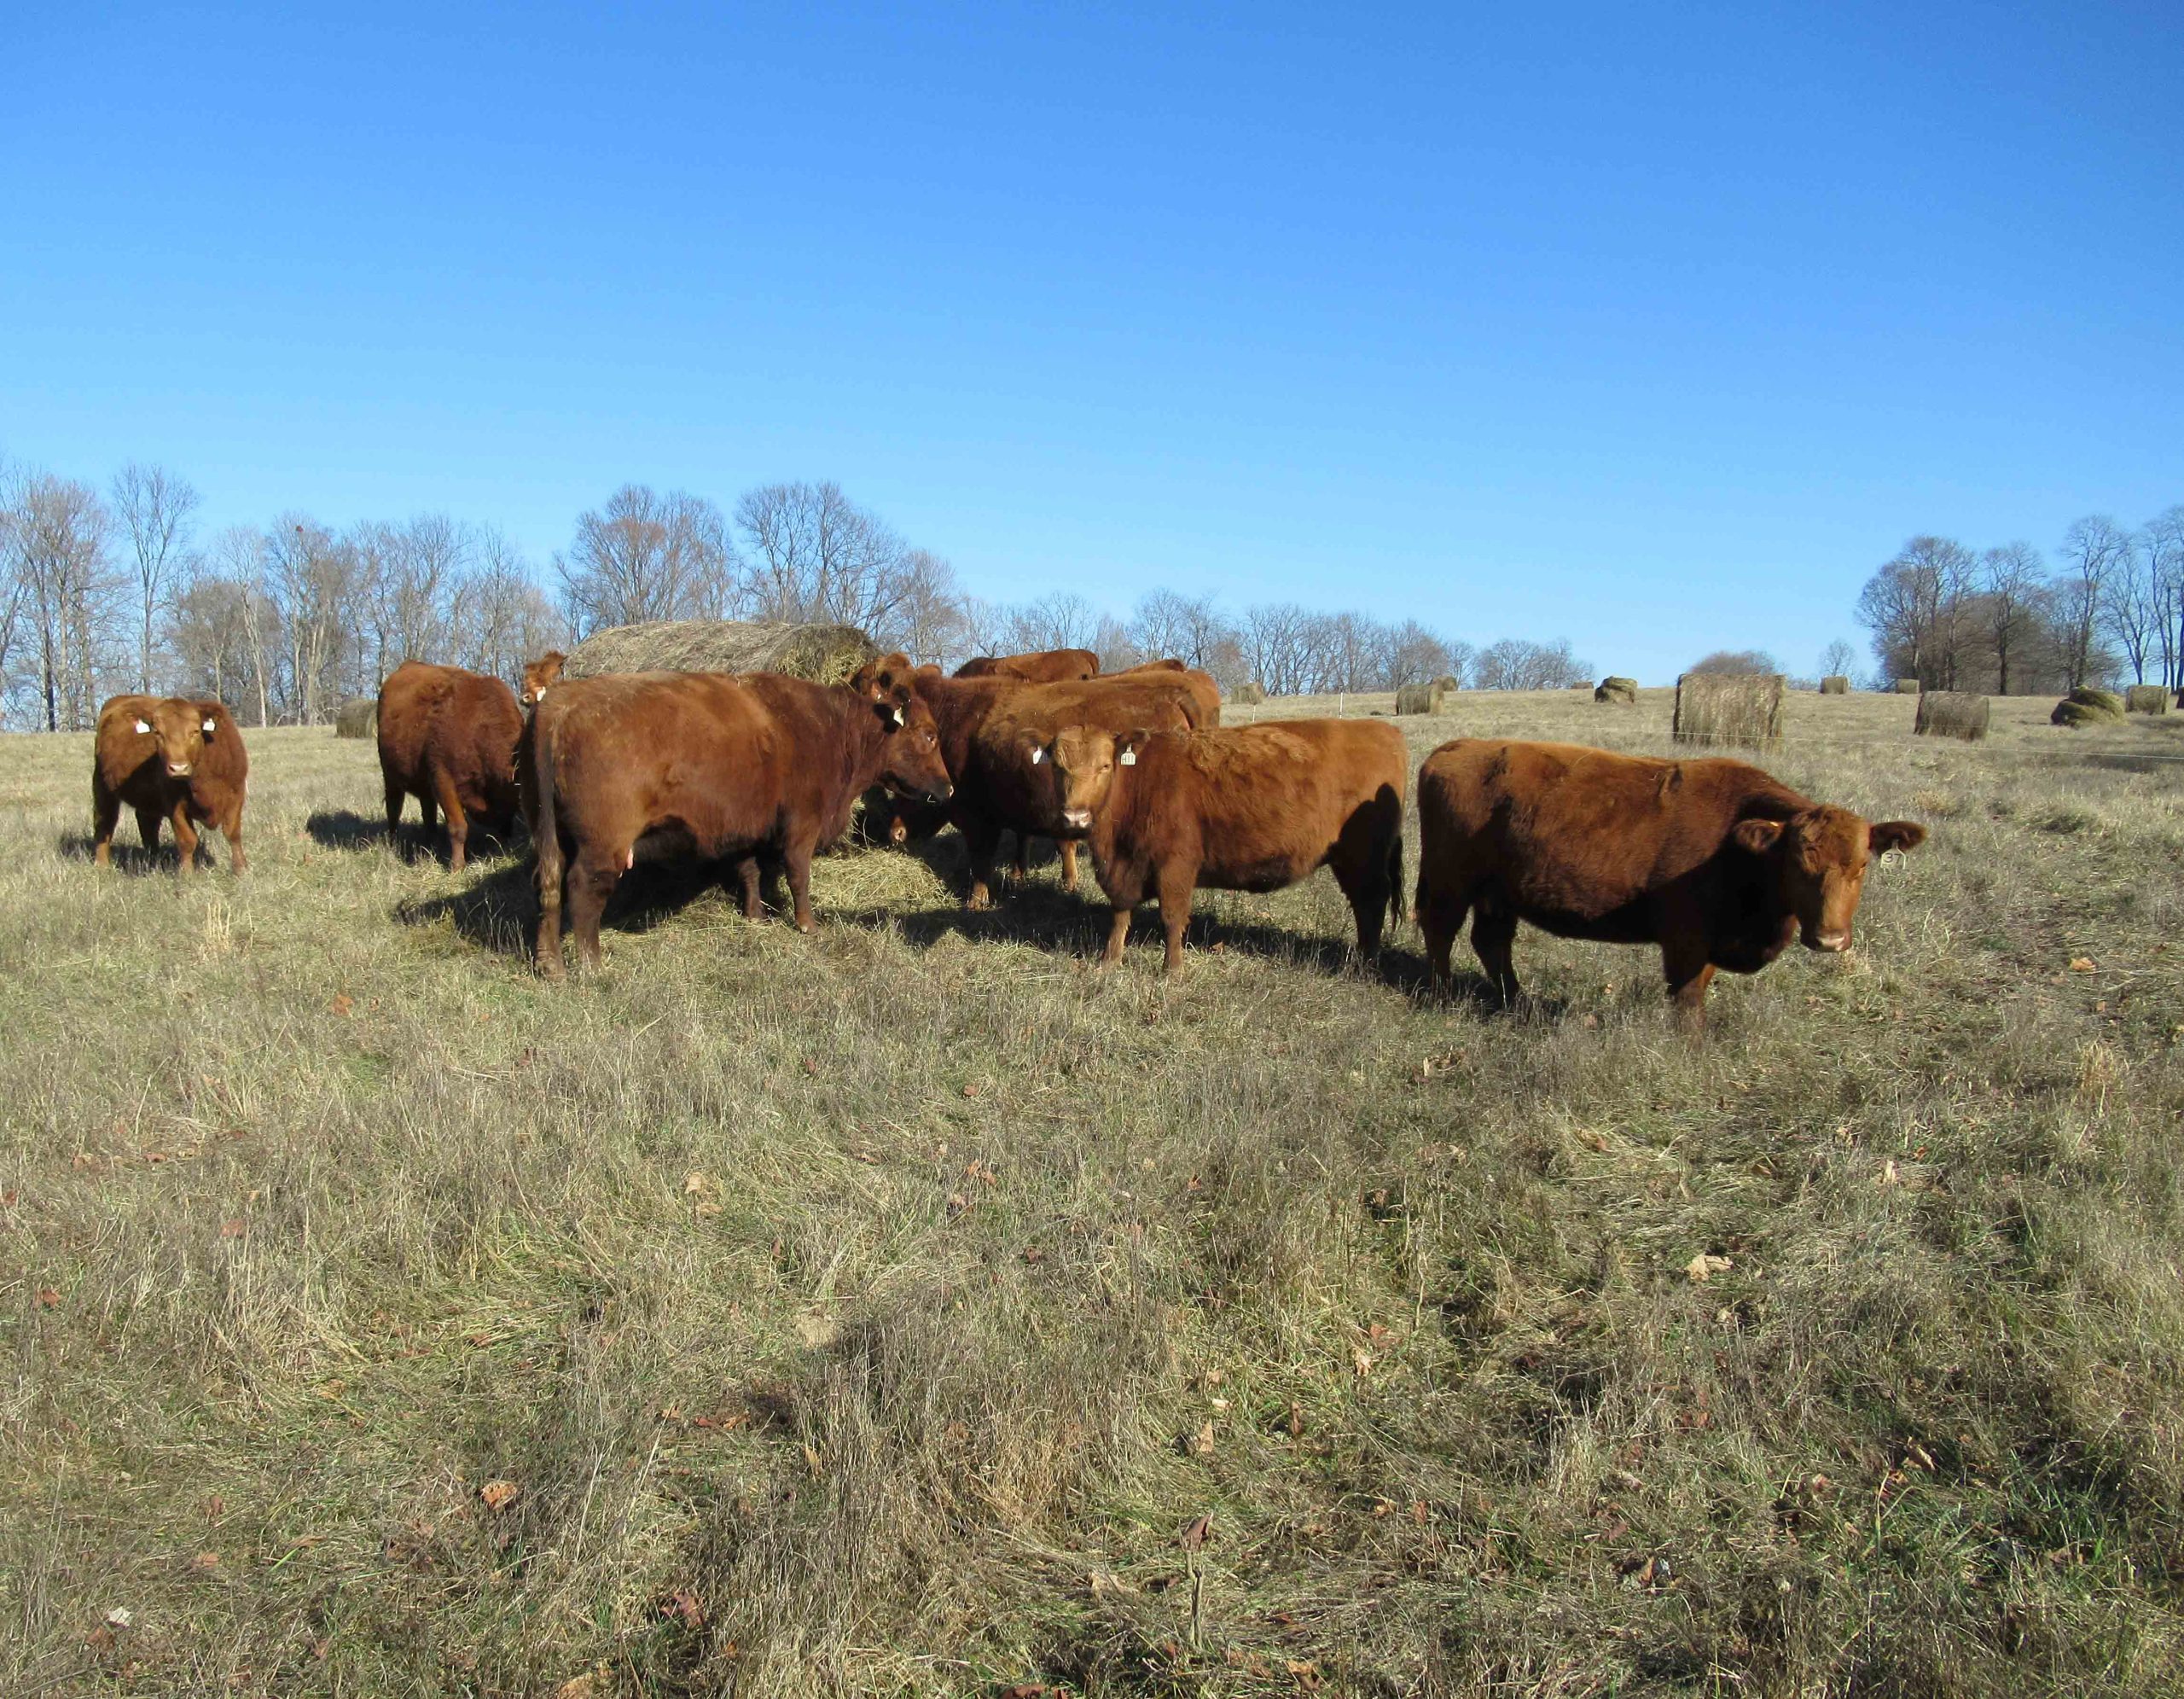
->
1859 507 2184 695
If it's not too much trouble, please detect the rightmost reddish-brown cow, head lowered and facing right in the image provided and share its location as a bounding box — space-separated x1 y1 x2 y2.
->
1417 738 1926 1031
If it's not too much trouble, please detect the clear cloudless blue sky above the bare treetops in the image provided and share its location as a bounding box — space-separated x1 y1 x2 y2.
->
0 4 2184 679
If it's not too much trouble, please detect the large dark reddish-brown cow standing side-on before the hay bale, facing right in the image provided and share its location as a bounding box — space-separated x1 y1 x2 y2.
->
524 655 948 978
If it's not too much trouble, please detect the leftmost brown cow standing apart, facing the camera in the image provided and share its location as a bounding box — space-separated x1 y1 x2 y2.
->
92 696 251 878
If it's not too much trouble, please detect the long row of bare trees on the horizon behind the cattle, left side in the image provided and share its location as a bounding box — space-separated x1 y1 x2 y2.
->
0 463 1592 730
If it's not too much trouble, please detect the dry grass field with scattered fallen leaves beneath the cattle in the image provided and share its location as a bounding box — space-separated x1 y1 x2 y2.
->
0 690 2184 1699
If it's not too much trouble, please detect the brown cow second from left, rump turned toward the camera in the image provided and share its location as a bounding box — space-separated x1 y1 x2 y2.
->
380 661 524 874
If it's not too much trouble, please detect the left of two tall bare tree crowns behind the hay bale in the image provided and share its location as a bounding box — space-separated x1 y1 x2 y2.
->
553 485 734 636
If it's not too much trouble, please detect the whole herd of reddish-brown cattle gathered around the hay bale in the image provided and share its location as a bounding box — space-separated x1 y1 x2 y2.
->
92 649 1926 1027
